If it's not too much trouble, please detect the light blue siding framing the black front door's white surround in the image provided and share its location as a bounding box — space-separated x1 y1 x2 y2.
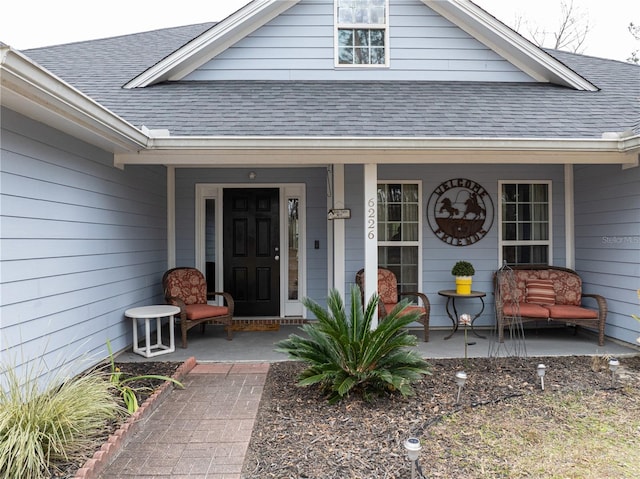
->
176 168 328 314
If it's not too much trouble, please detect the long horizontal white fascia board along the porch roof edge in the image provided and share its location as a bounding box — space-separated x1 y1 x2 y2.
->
114 137 637 167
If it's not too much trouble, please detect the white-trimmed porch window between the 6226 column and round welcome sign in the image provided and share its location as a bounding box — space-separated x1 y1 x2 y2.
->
378 183 422 292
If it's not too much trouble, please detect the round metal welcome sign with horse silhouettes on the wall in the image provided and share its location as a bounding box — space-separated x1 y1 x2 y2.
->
427 178 493 246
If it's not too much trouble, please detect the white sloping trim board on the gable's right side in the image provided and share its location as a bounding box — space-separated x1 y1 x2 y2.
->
422 0 598 91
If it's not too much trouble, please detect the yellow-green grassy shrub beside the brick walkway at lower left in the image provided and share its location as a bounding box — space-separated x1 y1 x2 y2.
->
0 367 122 479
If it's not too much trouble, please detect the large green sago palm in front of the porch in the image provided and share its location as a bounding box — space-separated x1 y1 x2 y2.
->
276 287 430 403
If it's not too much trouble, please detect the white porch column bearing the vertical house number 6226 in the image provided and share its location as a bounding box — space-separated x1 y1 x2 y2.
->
364 163 378 329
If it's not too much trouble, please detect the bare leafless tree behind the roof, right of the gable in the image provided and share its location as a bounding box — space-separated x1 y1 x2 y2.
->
514 0 591 53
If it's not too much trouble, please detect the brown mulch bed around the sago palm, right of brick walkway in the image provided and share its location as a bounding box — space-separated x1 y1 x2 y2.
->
242 357 640 479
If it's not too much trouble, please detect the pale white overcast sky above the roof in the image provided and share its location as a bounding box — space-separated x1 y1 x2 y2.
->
0 0 640 61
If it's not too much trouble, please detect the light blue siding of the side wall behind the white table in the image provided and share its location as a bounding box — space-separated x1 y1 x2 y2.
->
0 110 167 372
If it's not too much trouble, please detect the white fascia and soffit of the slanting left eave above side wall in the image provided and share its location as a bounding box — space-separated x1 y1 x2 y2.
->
0 46 149 152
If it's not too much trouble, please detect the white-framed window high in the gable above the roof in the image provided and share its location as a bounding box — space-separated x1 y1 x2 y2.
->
335 0 389 66
